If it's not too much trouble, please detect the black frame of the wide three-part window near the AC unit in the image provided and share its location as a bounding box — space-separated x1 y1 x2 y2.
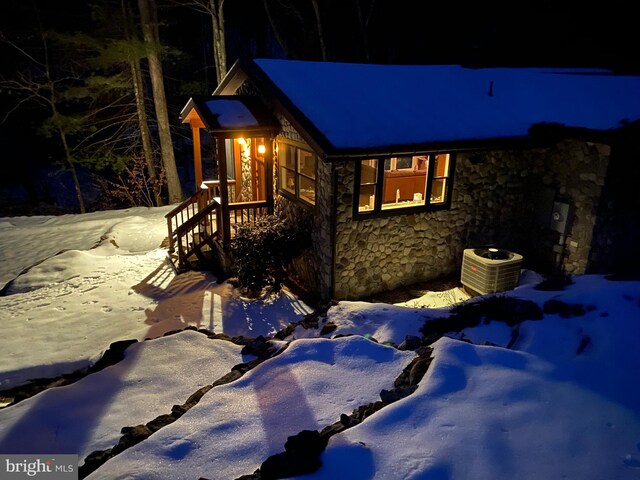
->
353 152 456 220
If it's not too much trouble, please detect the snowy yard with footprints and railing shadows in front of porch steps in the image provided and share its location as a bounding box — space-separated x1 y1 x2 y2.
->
0 207 311 389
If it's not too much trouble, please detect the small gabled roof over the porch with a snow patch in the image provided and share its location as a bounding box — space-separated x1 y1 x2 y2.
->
180 95 278 134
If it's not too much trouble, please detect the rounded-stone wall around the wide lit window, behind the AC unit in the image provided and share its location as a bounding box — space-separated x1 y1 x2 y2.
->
334 137 609 299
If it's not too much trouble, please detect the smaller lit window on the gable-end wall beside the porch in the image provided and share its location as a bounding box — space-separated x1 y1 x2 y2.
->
278 142 318 205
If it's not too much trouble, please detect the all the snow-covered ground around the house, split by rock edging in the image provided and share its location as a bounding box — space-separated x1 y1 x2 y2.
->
0 207 640 480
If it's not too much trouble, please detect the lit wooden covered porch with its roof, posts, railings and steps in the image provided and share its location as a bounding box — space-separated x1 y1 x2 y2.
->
166 95 278 269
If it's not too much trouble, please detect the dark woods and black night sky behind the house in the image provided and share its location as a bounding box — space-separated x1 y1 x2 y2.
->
0 0 640 215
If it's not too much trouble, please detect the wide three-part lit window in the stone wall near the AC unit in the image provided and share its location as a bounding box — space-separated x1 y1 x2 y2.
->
356 153 454 214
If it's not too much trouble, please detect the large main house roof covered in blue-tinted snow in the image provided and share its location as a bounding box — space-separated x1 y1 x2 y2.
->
216 59 640 152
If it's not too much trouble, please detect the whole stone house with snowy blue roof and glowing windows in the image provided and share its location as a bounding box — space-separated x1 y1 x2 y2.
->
175 60 640 299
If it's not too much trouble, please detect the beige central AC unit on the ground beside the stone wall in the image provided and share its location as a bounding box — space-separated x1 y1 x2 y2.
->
460 248 522 295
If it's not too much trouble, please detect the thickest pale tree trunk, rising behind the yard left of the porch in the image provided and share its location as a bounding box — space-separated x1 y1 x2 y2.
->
138 0 182 203
